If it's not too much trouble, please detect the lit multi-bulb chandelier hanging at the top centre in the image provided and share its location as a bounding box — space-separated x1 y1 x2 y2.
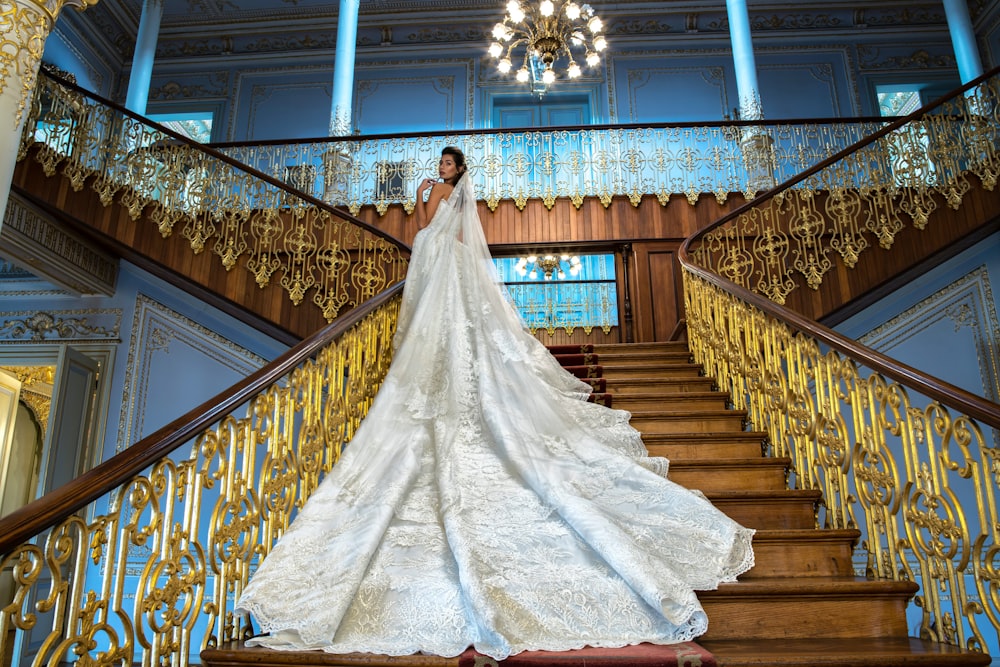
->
489 0 607 85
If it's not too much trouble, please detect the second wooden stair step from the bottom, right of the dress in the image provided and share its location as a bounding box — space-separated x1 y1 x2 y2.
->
698 577 919 640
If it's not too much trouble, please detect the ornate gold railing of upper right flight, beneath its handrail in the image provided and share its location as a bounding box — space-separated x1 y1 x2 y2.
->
692 74 1000 303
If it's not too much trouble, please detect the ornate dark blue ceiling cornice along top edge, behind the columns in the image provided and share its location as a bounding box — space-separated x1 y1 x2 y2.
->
60 0 960 65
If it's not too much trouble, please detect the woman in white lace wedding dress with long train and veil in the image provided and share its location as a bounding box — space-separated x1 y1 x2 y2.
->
237 147 753 660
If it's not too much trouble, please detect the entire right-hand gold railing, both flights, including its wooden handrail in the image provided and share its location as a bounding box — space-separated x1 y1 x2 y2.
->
680 66 1000 652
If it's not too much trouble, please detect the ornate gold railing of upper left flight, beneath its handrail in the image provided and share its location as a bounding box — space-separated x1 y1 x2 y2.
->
19 73 409 321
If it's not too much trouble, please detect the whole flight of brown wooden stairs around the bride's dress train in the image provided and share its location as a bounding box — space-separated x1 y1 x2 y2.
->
202 342 990 667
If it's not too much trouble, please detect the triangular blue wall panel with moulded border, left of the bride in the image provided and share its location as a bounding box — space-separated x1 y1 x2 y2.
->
115 294 266 453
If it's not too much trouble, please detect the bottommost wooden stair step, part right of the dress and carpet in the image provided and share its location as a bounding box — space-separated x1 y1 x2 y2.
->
698 637 991 667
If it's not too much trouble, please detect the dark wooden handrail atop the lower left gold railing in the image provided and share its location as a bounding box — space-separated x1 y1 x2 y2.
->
0 282 403 555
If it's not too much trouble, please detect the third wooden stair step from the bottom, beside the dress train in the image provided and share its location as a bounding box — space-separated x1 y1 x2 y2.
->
740 528 861 581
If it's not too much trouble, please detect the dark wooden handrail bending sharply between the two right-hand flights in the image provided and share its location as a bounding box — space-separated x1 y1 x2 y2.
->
677 67 1000 429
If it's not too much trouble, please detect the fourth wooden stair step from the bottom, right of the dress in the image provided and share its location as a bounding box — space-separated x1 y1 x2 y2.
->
705 489 821 530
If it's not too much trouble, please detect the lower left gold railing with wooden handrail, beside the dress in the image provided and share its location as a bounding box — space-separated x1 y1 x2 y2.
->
0 285 401 667
